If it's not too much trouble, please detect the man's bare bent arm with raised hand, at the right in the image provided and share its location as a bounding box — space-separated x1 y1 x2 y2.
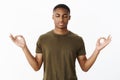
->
77 36 111 72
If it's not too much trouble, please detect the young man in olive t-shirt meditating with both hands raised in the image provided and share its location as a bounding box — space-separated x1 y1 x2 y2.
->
10 4 111 80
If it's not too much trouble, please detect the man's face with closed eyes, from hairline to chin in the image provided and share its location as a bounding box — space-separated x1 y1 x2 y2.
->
53 8 70 29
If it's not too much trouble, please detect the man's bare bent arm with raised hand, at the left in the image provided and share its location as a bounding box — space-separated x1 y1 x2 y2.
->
10 35 42 71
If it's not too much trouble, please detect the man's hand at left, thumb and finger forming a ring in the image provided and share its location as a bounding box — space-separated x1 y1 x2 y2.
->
10 34 26 48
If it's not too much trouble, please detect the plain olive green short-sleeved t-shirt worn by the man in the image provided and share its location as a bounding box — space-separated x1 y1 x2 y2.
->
36 30 86 80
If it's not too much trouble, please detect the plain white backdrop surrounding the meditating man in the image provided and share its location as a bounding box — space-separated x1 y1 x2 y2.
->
0 0 120 80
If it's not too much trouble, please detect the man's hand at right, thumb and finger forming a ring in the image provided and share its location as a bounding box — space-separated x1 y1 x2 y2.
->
96 35 111 51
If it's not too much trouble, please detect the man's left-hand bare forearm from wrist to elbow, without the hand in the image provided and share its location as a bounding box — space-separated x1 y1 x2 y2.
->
22 46 39 71
